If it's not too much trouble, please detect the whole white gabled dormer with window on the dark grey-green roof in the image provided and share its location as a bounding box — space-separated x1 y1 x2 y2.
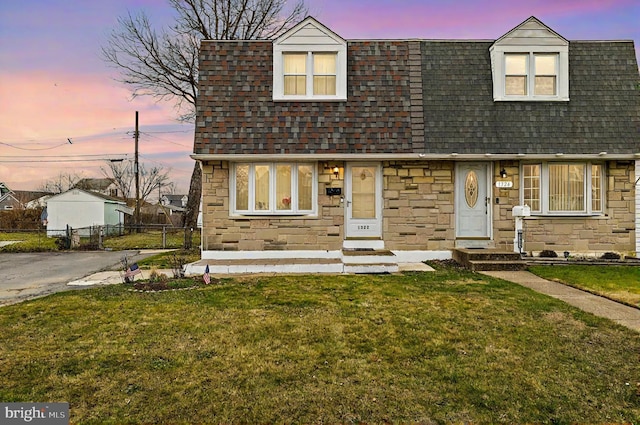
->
489 17 569 101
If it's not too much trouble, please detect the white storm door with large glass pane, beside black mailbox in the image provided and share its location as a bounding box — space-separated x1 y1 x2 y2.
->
344 164 382 239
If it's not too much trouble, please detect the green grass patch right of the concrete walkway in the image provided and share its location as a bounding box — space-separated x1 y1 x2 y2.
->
529 265 640 308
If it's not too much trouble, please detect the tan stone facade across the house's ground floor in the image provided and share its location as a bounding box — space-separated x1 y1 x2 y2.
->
202 161 636 255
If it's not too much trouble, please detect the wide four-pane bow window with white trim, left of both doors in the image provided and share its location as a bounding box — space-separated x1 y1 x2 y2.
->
230 162 317 215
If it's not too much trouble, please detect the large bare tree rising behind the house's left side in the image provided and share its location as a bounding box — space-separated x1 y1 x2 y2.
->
102 0 307 247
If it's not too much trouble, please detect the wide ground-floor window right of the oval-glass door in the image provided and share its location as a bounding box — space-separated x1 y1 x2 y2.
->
521 162 604 215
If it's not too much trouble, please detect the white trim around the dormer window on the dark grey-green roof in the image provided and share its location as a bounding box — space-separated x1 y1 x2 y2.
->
489 16 569 102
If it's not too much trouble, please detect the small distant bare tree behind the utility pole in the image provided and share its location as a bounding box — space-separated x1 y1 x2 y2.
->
100 161 173 205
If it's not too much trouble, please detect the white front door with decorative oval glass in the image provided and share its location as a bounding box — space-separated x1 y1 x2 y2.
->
456 162 491 242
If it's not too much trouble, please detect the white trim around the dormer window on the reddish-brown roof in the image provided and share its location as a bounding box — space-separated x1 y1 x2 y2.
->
273 17 347 101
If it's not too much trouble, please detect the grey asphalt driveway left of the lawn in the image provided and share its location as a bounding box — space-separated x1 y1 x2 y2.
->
0 250 155 306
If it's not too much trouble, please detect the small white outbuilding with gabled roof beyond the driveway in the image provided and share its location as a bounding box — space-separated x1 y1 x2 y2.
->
47 188 133 236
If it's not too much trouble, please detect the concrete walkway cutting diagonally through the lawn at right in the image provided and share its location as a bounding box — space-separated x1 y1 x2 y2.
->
482 271 640 332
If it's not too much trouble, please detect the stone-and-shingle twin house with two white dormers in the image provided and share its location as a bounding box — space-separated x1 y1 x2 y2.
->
193 17 640 271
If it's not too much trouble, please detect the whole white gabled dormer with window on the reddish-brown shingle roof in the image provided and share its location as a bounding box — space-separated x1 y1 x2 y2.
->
273 18 347 101
